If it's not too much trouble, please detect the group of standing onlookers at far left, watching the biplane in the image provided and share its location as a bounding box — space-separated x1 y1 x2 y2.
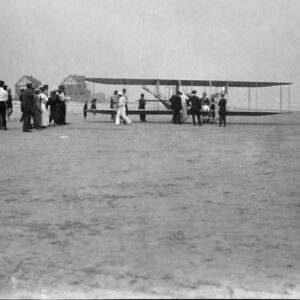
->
0 81 67 132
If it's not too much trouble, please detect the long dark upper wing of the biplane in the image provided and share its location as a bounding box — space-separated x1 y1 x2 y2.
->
85 77 292 88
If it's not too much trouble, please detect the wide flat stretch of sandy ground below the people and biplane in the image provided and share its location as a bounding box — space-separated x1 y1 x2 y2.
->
0 104 300 298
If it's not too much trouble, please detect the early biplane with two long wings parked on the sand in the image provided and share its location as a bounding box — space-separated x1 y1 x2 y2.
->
85 78 292 121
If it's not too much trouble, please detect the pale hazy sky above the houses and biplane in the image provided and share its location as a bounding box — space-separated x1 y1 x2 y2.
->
0 0 300 109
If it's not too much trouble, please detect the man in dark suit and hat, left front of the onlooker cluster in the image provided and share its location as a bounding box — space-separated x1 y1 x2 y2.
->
21 83 34 132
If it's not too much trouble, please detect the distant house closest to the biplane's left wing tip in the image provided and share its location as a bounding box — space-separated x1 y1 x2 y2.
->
61 75 91 101
